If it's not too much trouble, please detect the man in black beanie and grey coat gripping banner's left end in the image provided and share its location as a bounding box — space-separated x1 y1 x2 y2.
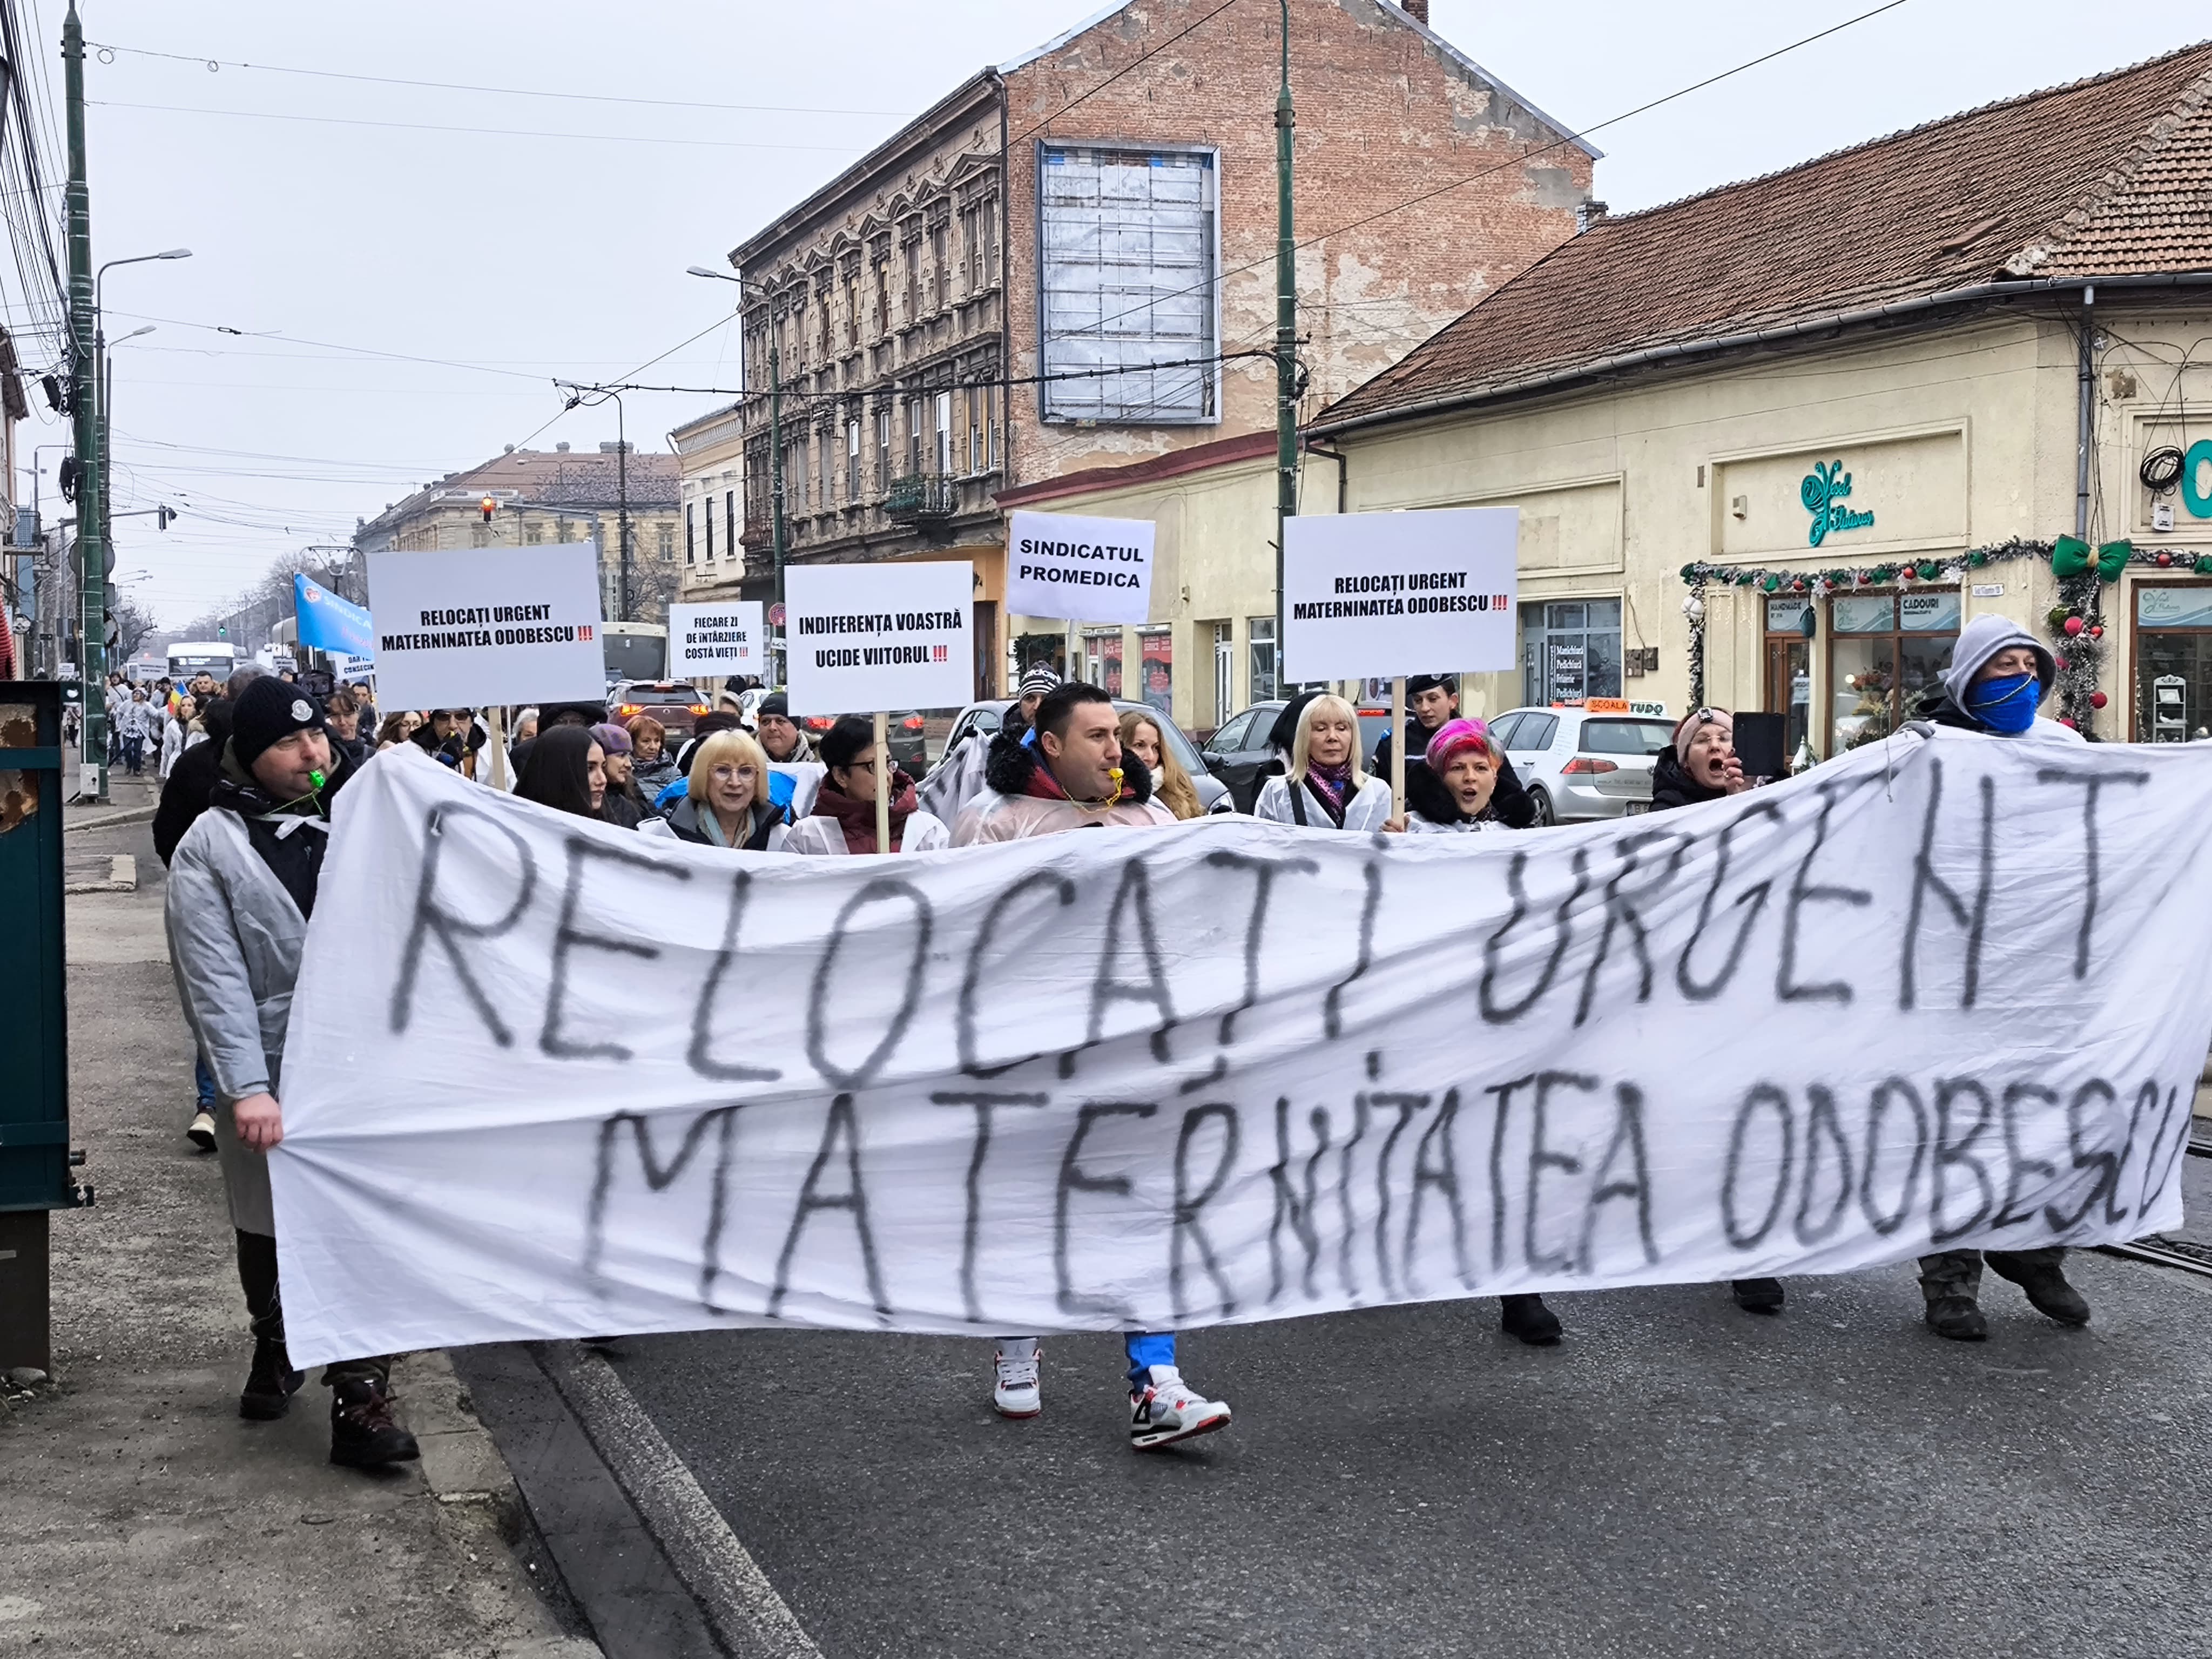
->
166 677 418 1469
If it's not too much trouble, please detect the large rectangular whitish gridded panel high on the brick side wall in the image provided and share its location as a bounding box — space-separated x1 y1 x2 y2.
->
1040 146 1219 424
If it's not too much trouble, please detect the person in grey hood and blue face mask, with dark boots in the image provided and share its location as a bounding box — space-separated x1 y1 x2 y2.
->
1916 617 2088 1343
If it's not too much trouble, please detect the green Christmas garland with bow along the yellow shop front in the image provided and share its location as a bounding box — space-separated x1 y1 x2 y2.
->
1681 535 2212 737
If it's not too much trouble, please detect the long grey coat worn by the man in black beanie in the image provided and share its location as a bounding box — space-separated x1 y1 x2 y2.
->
166 807 329 1237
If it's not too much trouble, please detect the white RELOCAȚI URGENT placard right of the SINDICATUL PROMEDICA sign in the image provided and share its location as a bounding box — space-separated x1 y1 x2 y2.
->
1283 507 1520 682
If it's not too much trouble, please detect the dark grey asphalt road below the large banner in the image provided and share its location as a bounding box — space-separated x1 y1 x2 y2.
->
619 1230 2212 1659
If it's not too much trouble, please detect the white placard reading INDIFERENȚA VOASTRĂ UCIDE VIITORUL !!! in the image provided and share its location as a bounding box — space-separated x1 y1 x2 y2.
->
783 559 975 714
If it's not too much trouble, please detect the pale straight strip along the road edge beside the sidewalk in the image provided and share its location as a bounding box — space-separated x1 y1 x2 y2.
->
537 1343 821 1659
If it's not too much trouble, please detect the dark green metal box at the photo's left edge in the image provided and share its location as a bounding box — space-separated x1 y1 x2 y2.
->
0 679 93 1372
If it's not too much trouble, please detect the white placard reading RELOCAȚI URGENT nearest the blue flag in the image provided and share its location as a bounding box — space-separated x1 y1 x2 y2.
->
369 542 606 708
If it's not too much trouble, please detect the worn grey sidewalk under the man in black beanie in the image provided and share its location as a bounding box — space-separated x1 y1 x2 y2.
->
0 810 599 1659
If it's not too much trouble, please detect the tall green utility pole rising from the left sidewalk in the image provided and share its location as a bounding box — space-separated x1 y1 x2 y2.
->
62 4 109 801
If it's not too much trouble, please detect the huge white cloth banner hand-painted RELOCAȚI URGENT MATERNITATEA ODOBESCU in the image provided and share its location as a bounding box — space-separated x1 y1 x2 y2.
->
272 732 2212 1363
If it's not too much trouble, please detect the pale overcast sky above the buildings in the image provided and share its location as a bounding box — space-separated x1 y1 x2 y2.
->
21 0 2208 626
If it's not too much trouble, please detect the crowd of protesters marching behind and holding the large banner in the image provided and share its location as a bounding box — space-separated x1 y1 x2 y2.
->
151 617 2090 1467
